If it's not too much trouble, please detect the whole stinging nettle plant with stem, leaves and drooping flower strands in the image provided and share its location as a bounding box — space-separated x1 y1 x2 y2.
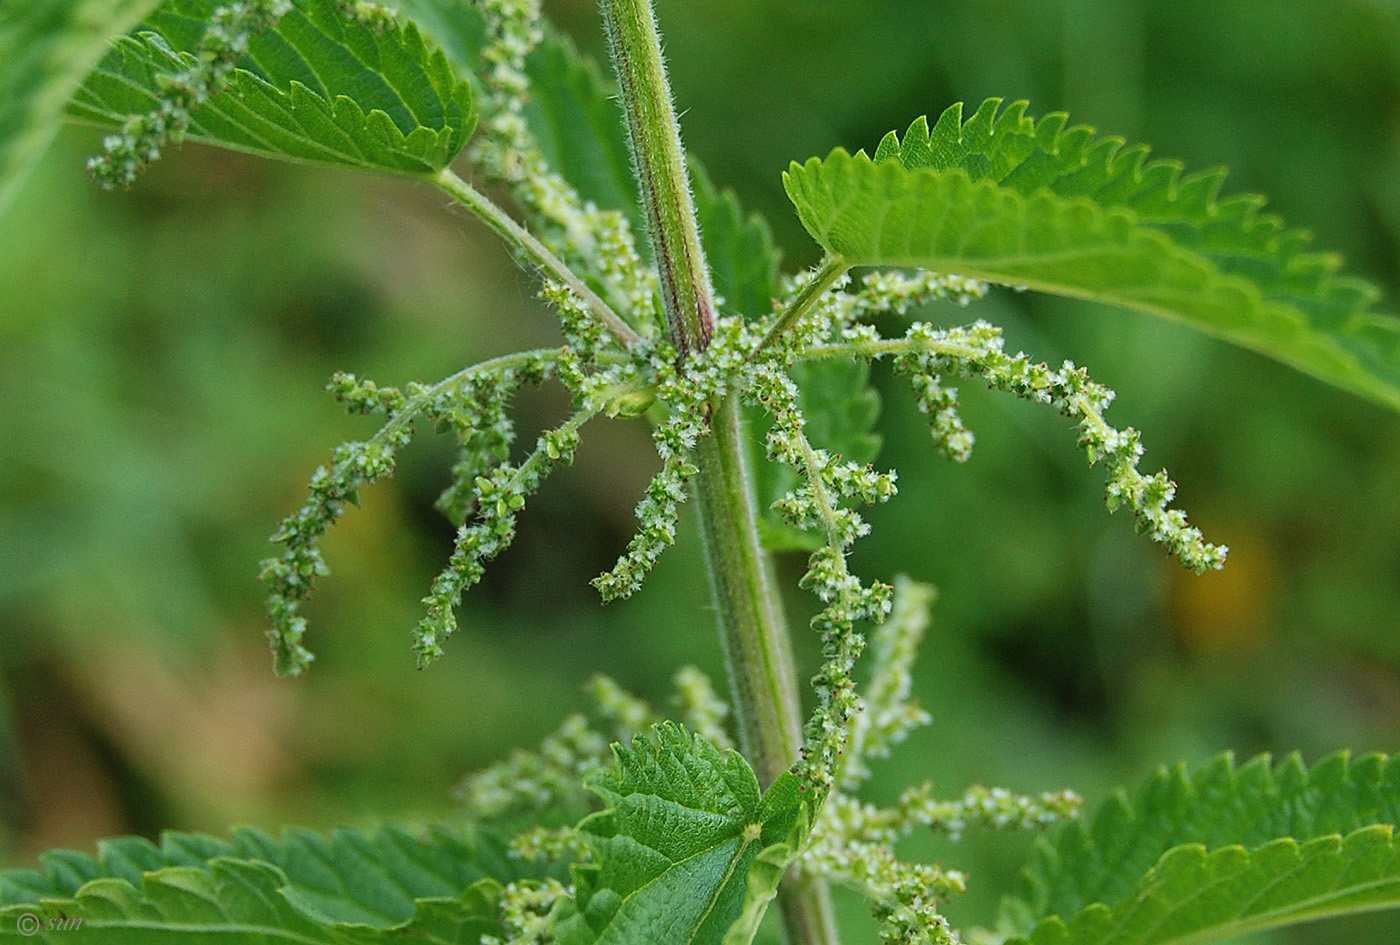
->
0 0 1400 945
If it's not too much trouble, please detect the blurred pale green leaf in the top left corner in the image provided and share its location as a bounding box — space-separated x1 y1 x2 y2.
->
0 0 160 213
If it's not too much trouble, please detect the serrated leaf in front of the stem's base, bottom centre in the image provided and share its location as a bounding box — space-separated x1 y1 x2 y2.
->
554 722 809 945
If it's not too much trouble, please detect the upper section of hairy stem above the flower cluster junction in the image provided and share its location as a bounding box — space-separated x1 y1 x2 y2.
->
602 0 714 357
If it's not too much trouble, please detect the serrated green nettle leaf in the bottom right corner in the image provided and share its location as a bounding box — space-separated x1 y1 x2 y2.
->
1002 755 1400 945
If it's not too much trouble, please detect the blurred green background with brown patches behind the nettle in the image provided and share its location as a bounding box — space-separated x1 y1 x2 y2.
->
0 0 1400 942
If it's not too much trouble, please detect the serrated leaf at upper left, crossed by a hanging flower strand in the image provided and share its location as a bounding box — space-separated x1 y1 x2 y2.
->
70 0 476 176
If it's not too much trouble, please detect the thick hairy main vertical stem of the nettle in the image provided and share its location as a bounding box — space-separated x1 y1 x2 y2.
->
601 0 837 945
